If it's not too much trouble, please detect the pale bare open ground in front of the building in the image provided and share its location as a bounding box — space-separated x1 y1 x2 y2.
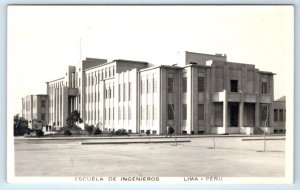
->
15 137 285 177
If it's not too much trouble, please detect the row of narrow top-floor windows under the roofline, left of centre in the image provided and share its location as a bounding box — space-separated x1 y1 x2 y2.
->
85 66 115 86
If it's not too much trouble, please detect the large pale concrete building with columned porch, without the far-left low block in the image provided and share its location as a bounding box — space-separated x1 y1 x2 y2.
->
21 52 286 134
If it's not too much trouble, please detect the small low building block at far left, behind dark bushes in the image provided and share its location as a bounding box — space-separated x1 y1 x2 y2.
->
22 94 49 126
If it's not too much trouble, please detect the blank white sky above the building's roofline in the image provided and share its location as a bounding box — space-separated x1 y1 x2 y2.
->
7 6 294 114
